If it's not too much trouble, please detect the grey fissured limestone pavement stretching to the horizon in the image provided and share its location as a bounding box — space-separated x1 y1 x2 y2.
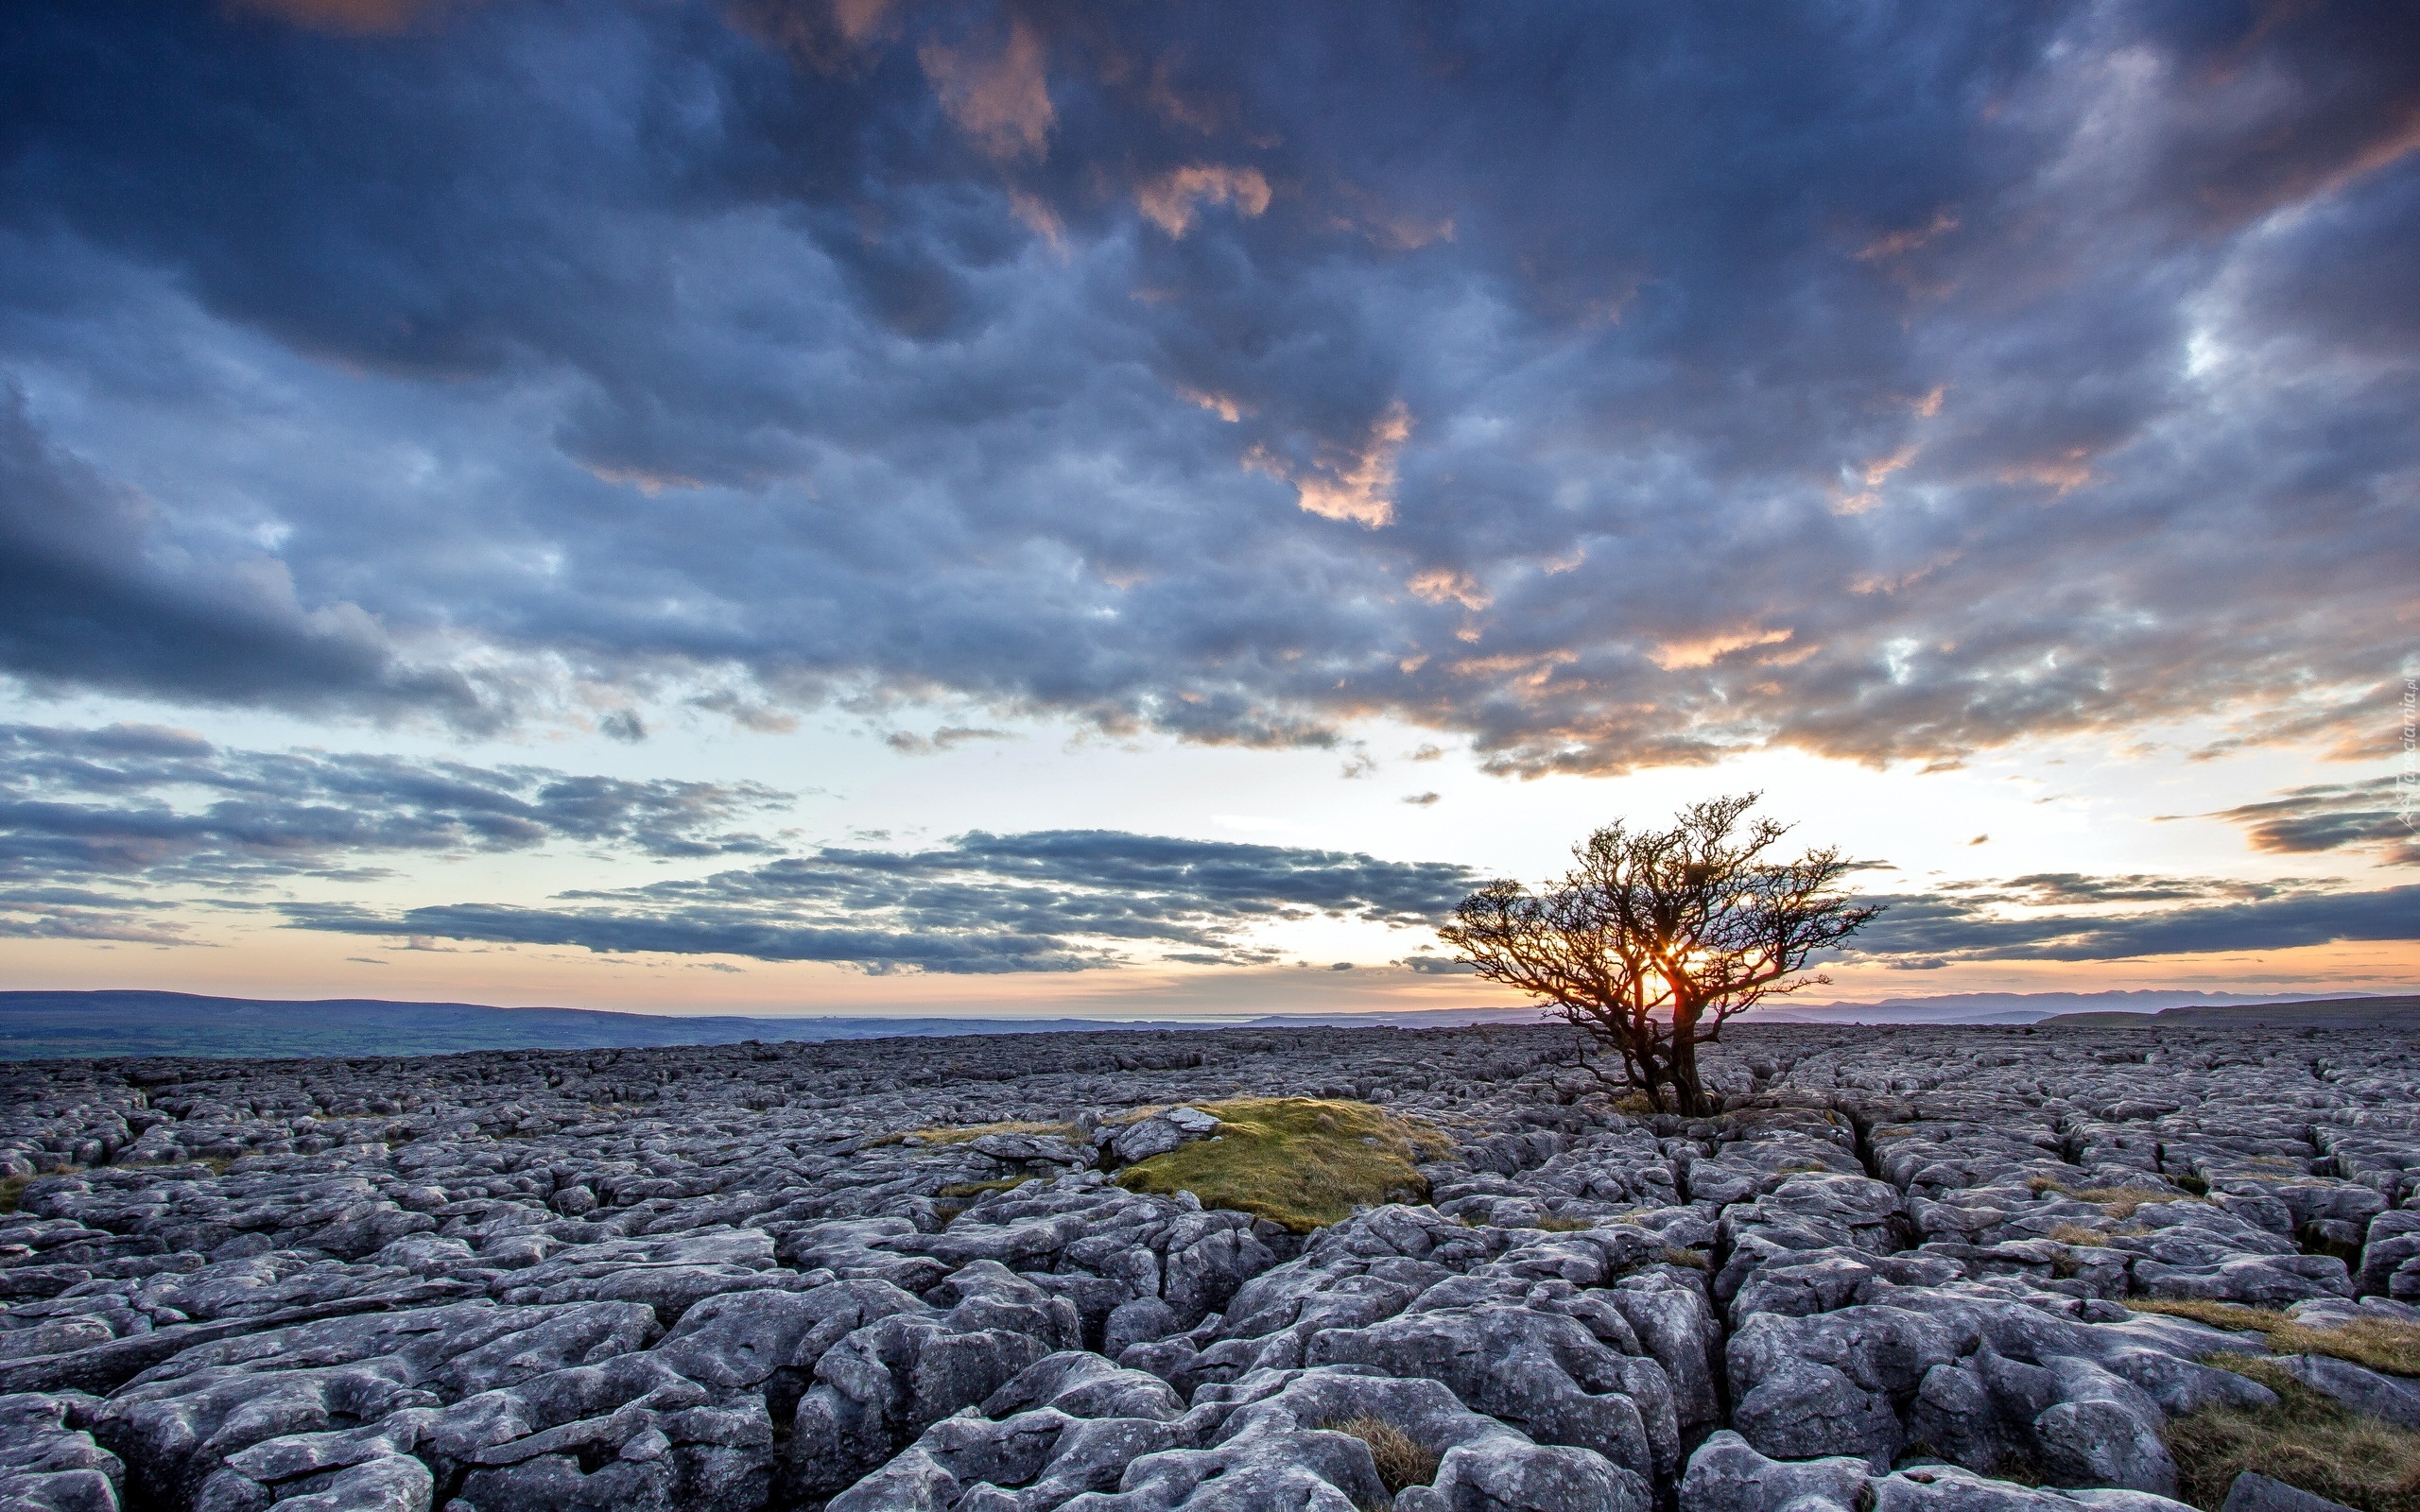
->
0 1025 2420 1512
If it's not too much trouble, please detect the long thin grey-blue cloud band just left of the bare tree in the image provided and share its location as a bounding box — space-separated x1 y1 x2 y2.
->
285 830 1481 972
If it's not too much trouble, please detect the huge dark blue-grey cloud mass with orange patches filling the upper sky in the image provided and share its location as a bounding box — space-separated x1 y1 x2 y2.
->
0 0 2420 772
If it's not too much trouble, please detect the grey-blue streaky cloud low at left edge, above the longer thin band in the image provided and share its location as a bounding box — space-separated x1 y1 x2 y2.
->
0 726 786 938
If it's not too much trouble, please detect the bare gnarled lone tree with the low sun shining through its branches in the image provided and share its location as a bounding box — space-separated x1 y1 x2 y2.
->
1438 794 1883 1118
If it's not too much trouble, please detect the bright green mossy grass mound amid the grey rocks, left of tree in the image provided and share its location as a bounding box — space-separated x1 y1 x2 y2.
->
1118 1098 1452 1234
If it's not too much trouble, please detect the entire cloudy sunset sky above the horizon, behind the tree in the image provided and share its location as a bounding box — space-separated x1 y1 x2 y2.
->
0 0 2420 1019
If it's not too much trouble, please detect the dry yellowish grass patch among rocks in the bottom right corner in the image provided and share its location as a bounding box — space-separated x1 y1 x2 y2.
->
2161 1354 2420 1512
